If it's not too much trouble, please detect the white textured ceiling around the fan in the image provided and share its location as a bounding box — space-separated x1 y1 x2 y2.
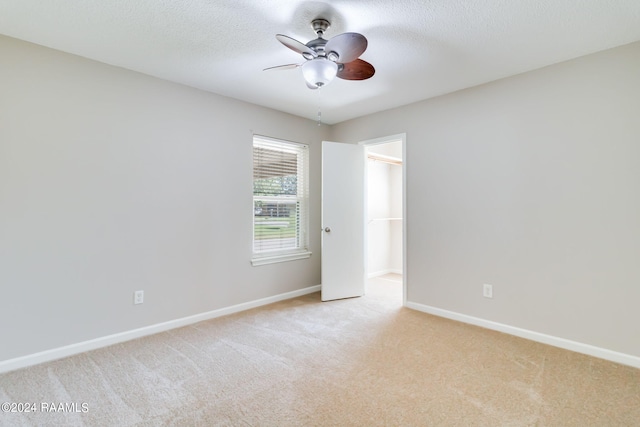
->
0 0 640 123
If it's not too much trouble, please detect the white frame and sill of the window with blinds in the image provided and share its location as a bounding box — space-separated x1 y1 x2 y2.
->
251 135 311 266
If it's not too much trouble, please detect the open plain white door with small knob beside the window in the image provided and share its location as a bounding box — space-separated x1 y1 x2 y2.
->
321 141 365 301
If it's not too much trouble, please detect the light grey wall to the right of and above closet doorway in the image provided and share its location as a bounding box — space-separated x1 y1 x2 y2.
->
331 43 640 356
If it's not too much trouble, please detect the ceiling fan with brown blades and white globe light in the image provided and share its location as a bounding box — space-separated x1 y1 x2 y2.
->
264 19 376 89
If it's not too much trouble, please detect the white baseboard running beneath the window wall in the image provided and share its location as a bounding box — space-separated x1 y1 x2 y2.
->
0 285 320 374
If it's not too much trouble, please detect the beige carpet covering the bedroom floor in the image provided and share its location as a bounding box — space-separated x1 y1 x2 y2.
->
0 279 640 426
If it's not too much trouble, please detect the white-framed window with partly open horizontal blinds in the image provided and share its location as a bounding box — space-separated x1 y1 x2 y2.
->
252 136 311 265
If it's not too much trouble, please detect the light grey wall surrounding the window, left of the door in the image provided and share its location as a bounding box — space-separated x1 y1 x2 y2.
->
0 37 327 361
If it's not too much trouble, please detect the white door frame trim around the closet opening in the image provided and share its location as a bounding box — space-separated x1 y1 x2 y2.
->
358 133 408 307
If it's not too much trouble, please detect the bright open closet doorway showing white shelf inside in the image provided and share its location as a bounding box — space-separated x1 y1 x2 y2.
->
363 135 406 304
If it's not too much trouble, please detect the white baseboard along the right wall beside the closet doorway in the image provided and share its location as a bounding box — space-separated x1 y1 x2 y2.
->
405 301 640 368
